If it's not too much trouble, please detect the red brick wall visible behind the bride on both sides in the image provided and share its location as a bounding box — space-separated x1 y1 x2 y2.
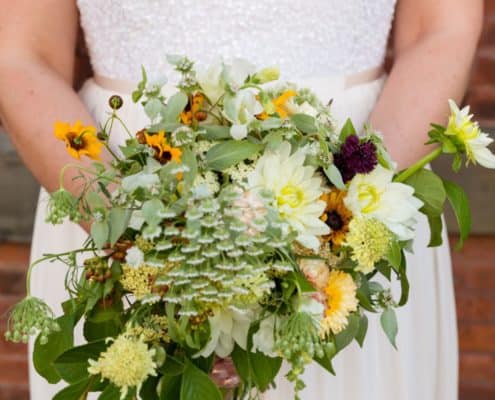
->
0 0 495 400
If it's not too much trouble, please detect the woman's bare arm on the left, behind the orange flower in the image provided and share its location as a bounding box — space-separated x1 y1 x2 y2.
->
0 0 97 196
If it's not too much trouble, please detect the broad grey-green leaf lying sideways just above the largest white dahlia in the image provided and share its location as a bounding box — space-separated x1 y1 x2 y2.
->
206 140 262 171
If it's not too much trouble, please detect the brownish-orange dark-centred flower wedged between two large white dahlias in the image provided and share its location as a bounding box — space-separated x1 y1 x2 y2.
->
320 189 352 246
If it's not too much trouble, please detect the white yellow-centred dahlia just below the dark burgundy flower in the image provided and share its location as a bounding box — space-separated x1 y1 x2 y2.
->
344 165 423 240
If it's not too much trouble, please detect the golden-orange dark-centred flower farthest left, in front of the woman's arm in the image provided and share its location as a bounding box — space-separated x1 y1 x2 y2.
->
53 121 103 160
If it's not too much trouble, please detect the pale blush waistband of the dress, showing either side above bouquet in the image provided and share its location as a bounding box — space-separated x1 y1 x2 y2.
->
93 65 385 94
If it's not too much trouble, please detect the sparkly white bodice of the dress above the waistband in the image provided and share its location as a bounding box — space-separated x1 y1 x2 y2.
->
77 0 396 80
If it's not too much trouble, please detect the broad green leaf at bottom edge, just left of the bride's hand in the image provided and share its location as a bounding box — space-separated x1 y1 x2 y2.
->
180 359 223 400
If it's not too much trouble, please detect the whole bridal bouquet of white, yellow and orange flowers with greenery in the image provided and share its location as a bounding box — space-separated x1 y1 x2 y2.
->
6 57 495 400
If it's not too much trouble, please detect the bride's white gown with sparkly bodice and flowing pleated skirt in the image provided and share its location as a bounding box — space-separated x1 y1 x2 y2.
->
30 0 457 400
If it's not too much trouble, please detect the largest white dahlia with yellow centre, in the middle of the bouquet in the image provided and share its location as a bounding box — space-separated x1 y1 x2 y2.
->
248 142 329 250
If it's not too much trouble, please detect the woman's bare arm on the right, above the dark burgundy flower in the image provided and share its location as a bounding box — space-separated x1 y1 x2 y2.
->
371 0 483 167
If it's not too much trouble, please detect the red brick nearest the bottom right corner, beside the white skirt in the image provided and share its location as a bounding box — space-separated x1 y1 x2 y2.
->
459 353 495 387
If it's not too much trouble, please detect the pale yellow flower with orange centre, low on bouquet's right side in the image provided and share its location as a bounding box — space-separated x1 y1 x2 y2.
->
320 270 358 337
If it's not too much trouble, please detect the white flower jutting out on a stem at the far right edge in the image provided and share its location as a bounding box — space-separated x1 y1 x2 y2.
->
445 100 495 168
